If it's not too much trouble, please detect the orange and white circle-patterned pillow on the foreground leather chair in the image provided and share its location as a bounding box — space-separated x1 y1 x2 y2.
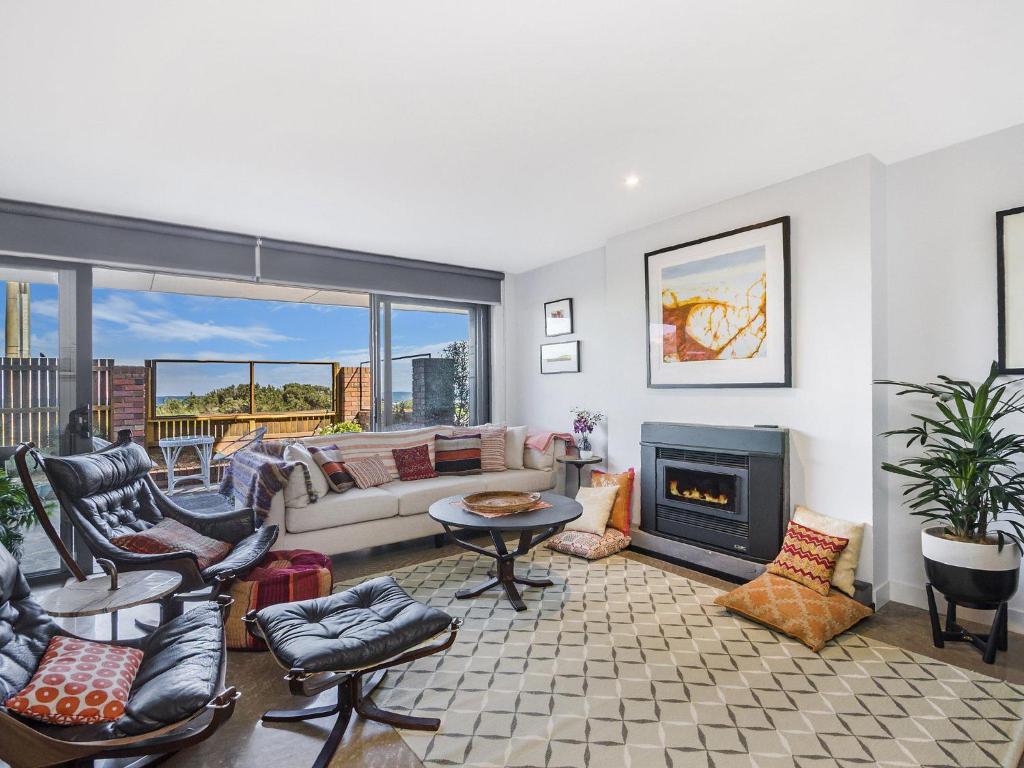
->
4 635 142 725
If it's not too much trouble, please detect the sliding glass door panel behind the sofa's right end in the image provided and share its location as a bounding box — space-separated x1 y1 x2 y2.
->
374 297 489 430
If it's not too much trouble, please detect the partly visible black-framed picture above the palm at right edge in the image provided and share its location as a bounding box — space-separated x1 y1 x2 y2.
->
995 207 1024 374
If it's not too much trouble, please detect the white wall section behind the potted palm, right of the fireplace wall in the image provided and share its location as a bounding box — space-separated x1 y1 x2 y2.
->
880 126 1024 629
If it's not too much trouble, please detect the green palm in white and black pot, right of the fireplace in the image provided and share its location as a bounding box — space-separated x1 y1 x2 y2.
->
879 362 1024 608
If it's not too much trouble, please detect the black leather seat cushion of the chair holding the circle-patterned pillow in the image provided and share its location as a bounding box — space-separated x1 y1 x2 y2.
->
37 603 225 741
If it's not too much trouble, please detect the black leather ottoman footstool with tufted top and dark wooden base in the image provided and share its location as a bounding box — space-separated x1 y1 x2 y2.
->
245 577 462 768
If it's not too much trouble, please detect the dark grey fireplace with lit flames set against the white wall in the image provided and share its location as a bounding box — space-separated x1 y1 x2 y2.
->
640 422 788 563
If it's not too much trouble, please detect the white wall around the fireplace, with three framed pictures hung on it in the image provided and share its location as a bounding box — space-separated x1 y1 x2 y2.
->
508 158 884 580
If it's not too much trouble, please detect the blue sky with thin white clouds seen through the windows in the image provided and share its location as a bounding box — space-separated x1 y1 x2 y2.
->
18 284 468 396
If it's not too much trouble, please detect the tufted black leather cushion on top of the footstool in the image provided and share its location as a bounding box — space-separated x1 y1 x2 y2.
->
256 577 452 672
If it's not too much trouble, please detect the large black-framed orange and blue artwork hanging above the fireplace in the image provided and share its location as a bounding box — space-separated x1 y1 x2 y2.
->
646 216 790 387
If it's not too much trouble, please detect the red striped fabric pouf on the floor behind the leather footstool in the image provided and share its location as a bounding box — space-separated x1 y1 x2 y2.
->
224 549 334 650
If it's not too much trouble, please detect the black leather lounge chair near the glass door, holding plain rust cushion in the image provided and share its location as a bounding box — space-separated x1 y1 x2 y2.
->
14 429 278 624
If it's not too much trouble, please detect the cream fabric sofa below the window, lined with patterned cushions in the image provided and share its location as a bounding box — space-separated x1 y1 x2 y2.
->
247 427 565 555
